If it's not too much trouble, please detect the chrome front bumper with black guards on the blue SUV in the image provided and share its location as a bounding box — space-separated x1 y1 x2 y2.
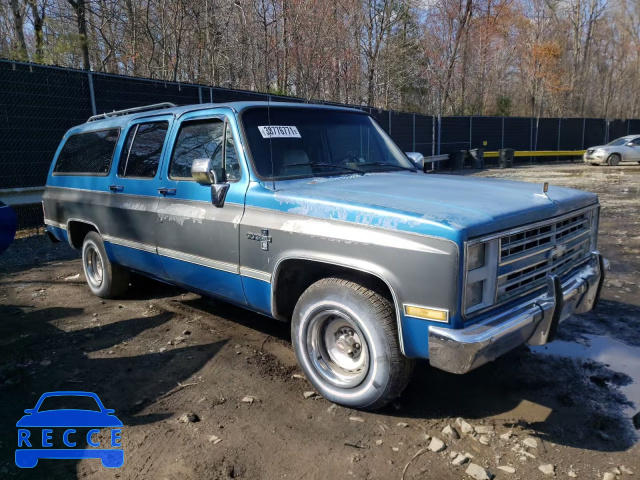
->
429 252 605 373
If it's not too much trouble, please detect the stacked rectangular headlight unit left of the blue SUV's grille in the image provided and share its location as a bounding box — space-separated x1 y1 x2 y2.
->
463 239 500 313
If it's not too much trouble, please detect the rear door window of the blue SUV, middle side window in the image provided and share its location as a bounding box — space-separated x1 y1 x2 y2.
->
118 122 169 178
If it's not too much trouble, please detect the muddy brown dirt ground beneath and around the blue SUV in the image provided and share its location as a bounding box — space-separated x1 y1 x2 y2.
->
0 165 640 480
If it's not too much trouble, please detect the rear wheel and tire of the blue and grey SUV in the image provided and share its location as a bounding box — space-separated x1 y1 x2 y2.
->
82 232 130 298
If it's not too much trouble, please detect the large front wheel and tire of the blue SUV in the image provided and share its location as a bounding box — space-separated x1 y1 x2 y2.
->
291 278 413 410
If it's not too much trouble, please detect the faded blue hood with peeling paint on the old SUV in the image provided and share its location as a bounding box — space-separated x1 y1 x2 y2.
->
277 172 598 239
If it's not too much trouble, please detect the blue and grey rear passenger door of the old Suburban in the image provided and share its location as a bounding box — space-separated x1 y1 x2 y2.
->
105 115 172 278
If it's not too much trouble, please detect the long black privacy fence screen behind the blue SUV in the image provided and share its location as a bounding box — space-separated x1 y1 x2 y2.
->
0 60 640 226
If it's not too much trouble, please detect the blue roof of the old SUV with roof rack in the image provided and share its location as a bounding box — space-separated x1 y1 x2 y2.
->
68 101 366 133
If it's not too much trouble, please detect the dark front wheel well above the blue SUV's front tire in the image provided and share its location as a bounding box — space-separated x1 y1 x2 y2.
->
274 259 395 320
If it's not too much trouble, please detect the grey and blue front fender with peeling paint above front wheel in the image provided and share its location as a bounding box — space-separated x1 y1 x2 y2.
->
239 207 459 357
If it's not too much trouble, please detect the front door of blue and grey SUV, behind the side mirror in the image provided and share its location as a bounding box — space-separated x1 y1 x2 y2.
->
157 111 248 304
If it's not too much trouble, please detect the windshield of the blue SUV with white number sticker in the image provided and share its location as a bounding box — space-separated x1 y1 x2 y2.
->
241 107 415 179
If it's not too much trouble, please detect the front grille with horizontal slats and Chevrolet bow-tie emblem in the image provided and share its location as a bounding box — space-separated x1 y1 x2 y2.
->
496 209 596 303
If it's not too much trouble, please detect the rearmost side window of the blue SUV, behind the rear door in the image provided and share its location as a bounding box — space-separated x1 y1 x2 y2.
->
53 128 120 175
